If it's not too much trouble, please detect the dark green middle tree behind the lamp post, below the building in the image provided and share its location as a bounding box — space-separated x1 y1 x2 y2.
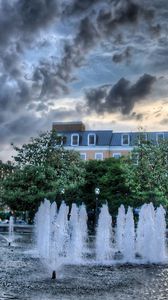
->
79 158 129 214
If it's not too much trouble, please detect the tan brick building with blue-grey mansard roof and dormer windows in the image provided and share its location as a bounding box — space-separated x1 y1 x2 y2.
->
52 122 168 160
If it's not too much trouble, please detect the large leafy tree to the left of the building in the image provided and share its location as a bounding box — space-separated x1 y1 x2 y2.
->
2 131 85 210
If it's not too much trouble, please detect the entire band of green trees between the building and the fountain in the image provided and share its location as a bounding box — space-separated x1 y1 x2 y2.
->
0 132 168 215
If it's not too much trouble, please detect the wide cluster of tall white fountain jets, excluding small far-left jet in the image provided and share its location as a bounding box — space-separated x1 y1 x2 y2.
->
36 199 166 278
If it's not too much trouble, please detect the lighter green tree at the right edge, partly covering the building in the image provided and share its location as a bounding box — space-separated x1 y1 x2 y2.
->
123 140 168 206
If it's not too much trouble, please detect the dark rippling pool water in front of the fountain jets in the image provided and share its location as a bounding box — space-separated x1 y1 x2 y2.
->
0 235 168 300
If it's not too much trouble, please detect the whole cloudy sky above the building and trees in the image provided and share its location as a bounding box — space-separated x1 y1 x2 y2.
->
0 0 168 161
